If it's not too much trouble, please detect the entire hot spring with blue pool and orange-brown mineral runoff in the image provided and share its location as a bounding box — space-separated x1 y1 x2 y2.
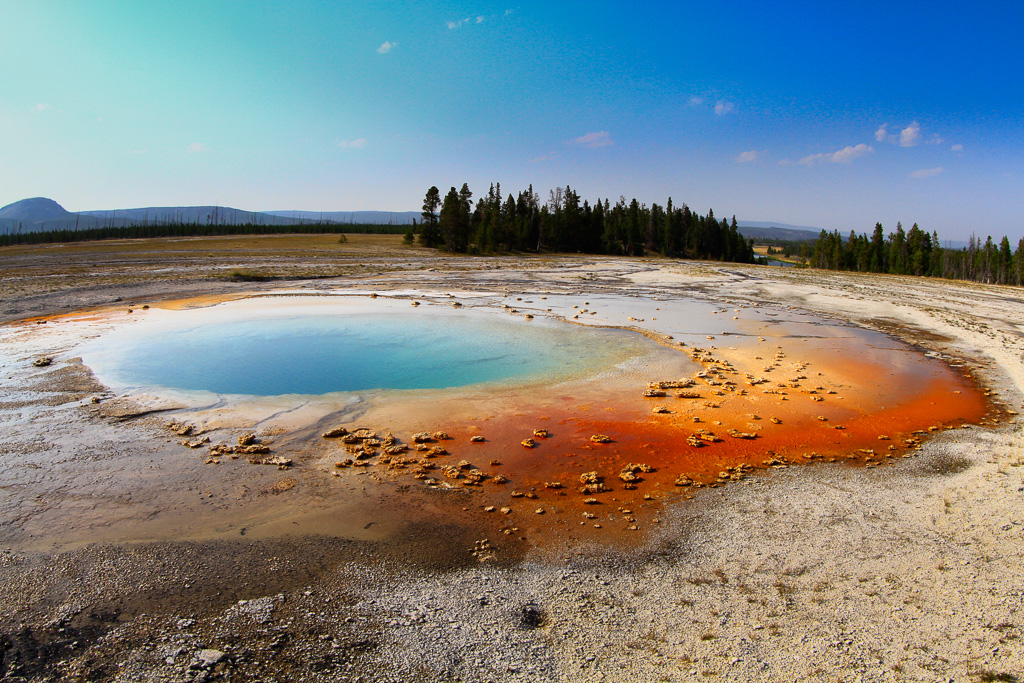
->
0 292 987 545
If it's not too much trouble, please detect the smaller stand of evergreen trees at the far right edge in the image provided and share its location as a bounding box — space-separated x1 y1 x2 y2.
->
810 223 1024 287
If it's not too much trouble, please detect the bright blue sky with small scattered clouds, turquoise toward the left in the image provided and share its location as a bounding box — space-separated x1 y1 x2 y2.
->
0 0 1024 245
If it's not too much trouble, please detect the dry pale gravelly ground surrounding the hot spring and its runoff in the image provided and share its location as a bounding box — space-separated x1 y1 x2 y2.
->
0 237 1024 682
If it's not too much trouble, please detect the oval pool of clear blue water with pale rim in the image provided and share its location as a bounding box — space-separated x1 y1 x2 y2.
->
81 306 636 396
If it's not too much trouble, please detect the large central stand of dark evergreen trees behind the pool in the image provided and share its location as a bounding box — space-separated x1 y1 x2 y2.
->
419 183 754 263
